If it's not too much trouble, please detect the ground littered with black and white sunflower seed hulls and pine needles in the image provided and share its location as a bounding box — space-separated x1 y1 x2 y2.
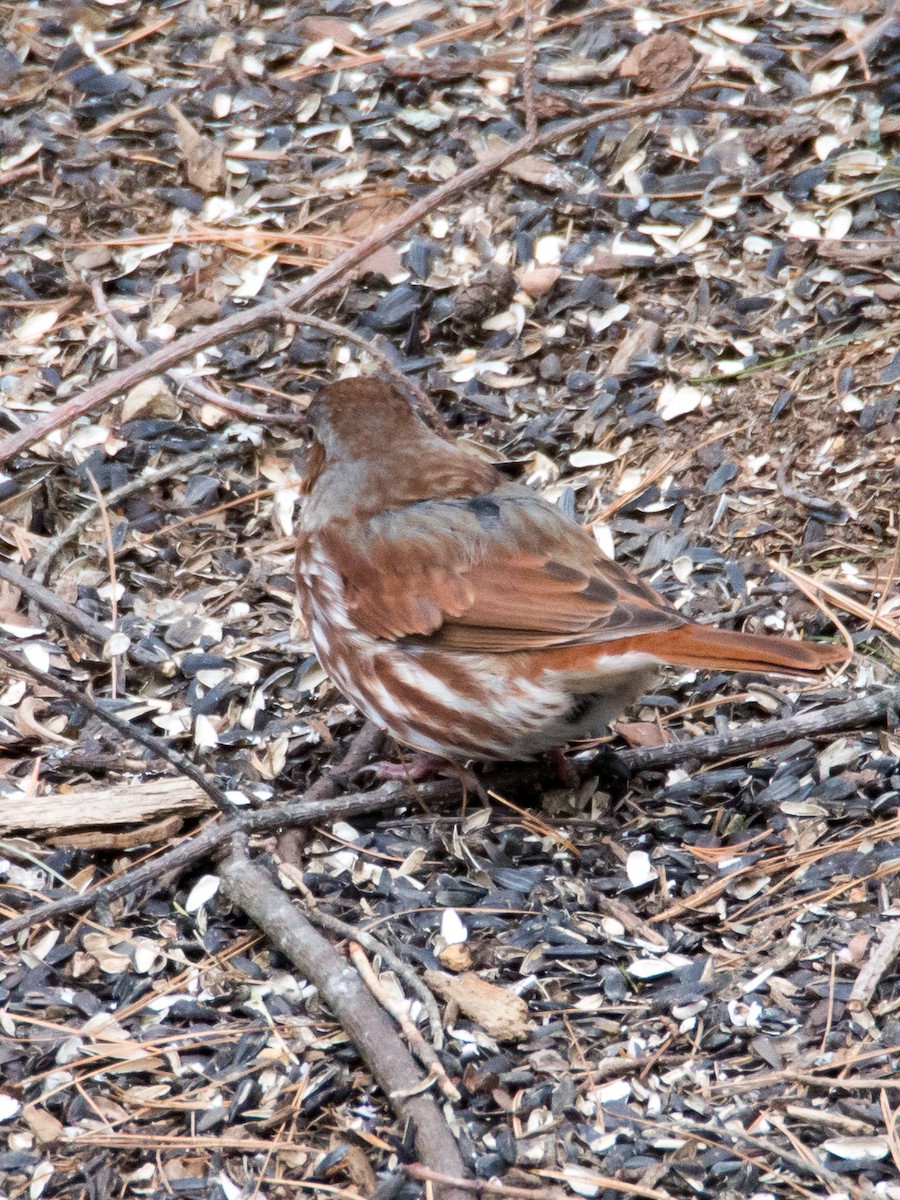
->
0 7 900 1200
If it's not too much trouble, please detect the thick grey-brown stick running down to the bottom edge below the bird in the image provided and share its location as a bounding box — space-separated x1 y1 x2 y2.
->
220 846 466 1200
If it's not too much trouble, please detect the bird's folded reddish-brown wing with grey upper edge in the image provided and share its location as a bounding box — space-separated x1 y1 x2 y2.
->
319 485 683 653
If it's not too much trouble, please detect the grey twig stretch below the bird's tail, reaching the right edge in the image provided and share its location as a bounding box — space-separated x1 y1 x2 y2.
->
616 684 900 772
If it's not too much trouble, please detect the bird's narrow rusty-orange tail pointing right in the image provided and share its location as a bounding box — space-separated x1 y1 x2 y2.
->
638 624 848 676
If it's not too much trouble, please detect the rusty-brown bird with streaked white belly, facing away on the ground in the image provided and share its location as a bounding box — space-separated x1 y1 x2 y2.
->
296 376 846 763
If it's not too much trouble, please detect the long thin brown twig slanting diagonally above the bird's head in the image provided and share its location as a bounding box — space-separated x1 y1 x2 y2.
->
0 79 694 463
